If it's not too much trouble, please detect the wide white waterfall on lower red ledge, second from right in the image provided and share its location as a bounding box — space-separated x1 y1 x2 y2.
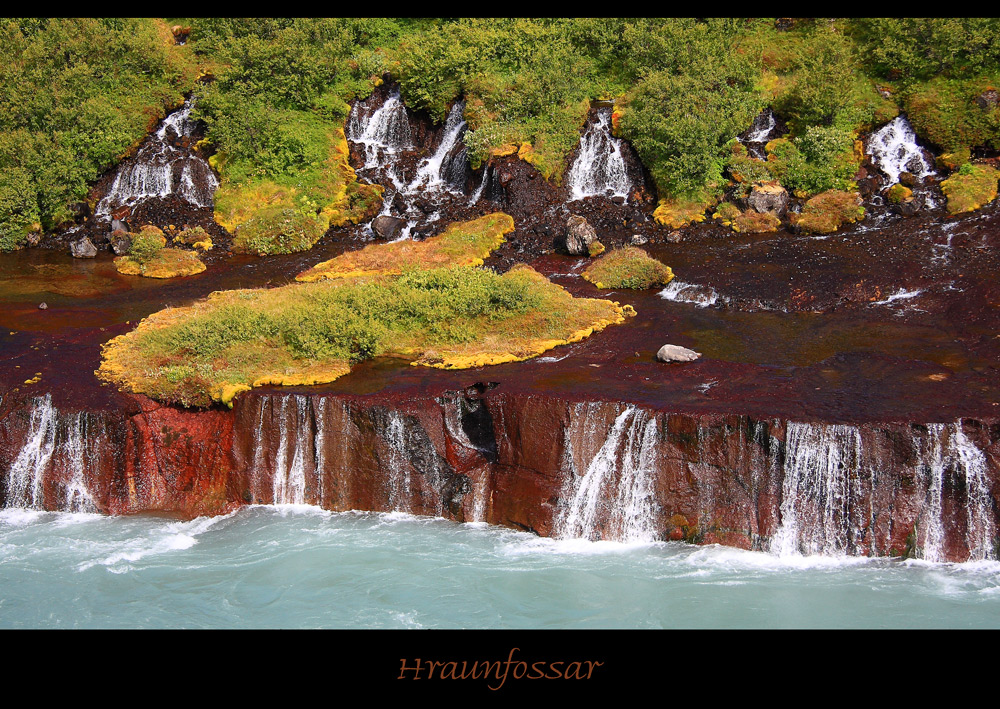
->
771 422 863 556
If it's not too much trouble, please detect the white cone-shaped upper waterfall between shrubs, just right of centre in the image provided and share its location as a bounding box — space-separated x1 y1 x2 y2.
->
566 108 632 200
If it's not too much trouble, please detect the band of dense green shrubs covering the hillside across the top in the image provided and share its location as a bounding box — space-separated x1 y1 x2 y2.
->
9 18 1000 250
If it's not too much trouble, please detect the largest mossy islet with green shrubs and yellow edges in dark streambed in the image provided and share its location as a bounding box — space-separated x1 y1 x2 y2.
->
97 266 635 406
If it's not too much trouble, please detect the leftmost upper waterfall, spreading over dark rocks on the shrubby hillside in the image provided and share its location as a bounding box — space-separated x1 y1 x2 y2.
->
95 99 219 219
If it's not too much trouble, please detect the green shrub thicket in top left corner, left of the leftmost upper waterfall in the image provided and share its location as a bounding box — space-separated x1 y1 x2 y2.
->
0 18 194 250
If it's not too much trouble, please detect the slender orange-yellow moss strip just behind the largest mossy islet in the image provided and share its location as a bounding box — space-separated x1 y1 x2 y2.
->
295 212 514 281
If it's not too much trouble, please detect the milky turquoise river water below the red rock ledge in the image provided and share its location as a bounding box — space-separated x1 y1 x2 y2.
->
0 506 1000 629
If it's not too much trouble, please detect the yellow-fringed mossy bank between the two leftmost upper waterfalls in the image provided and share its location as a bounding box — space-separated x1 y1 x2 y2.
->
214 126 384 256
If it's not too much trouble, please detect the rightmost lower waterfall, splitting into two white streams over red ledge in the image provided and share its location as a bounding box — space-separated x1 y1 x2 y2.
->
917 421 996 561
